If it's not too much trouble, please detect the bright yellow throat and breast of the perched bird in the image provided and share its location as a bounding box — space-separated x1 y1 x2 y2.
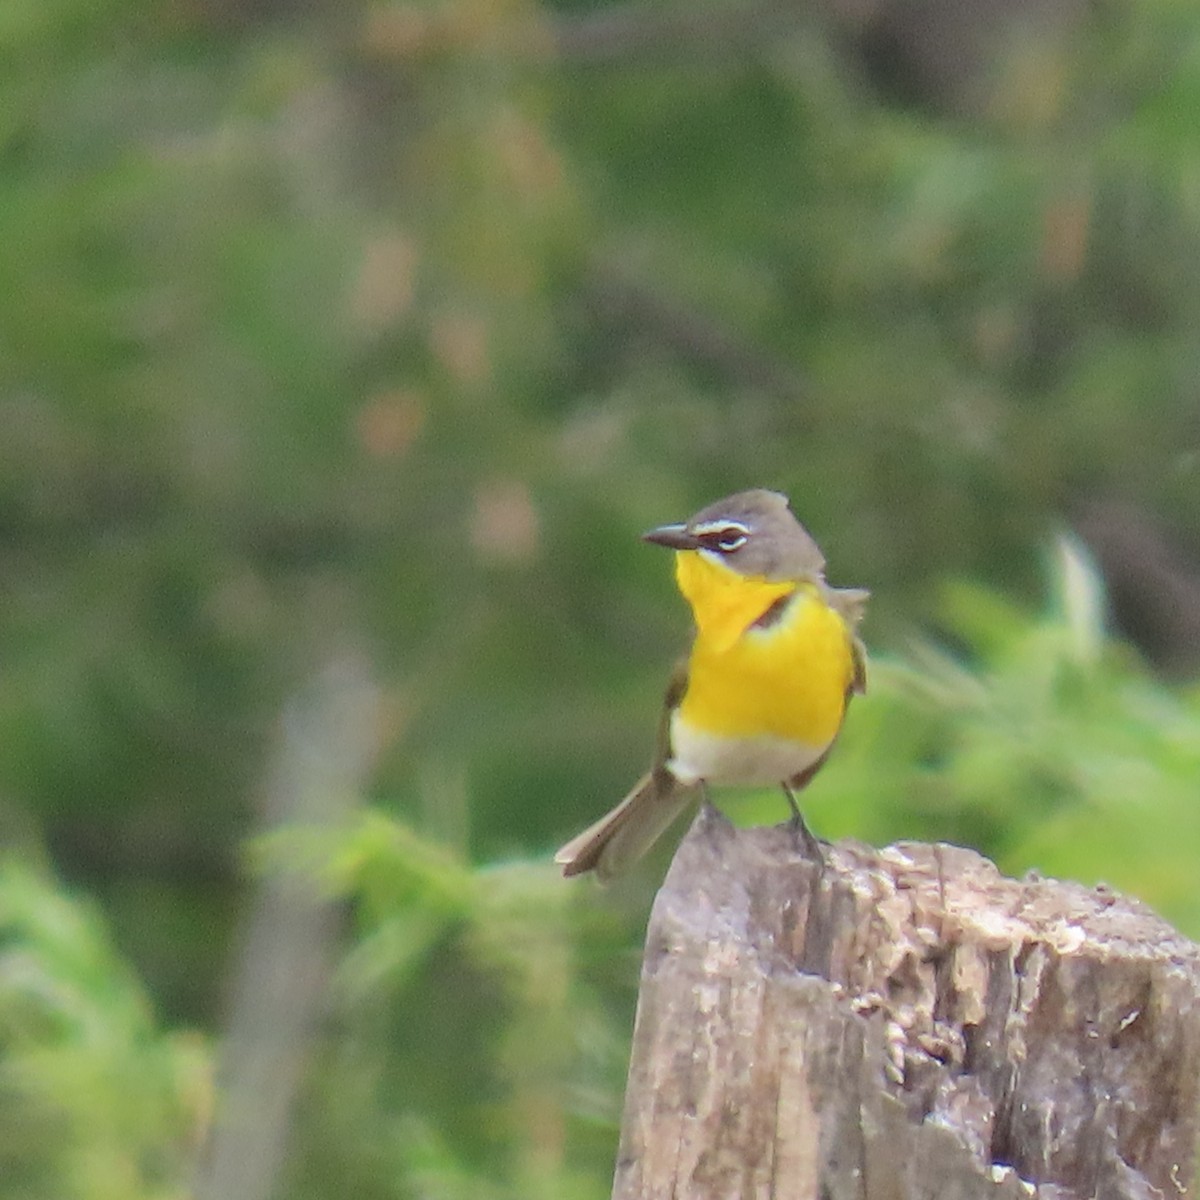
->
676 551 853 749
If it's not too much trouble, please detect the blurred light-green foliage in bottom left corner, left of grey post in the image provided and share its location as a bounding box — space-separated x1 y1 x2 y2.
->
0 860 206 1200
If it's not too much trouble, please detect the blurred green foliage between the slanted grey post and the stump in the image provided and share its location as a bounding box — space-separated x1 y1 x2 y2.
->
263 812 624 1200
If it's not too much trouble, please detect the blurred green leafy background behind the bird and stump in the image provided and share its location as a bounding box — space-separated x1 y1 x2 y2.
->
7 0 1200 1200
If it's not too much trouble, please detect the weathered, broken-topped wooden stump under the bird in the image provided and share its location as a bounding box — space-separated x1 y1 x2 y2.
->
613 806 1200 1200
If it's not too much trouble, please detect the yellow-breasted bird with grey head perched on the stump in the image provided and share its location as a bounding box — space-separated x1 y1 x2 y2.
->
554 488 870 880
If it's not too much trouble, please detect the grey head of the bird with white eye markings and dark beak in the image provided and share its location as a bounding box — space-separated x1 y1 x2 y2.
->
643 488 824 580
